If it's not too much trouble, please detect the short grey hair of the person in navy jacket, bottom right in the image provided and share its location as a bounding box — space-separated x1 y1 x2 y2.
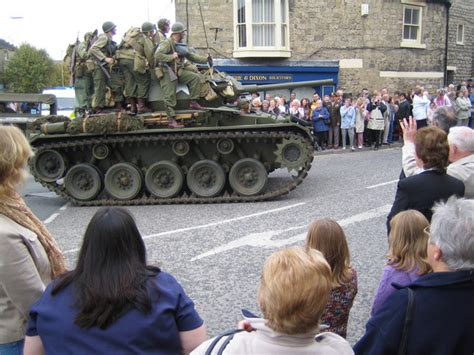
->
430 197 474 271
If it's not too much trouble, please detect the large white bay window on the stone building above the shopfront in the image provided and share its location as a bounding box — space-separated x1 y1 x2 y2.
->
234 0 291 58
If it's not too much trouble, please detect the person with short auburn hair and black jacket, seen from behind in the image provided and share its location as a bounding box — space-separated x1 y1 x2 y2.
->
387 127 464 232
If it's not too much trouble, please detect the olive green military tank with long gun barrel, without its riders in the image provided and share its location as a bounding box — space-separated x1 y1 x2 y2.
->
30 73 332 206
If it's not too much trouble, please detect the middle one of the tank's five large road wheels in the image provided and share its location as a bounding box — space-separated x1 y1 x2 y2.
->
145 160 184 198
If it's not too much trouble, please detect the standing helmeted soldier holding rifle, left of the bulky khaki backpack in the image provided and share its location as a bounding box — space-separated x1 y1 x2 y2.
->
88 21 123 113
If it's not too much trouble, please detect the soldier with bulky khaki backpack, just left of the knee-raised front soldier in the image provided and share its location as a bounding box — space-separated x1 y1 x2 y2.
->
117 22 155 113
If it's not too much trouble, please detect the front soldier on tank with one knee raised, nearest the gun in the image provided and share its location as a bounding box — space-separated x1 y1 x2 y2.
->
155 22 212 128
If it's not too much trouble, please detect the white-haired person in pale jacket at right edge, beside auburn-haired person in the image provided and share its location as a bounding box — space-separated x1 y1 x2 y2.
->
447 126 474 199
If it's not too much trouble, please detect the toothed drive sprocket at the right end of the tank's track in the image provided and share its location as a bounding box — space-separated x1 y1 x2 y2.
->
274 137 308 171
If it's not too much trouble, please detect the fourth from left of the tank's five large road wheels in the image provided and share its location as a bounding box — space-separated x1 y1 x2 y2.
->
186 160 225 197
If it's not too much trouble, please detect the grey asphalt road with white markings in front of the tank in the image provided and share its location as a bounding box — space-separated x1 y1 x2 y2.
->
24 145 401 344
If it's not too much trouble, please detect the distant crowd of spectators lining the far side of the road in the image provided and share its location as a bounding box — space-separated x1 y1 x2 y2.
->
247 81 474 151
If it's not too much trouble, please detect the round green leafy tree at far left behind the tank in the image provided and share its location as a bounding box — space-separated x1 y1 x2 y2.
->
5 44 54 93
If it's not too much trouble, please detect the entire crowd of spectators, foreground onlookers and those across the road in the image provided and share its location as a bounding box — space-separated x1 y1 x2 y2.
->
0 80 474 355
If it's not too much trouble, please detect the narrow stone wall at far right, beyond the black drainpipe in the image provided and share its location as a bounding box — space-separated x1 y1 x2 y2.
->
448 0 474 82
